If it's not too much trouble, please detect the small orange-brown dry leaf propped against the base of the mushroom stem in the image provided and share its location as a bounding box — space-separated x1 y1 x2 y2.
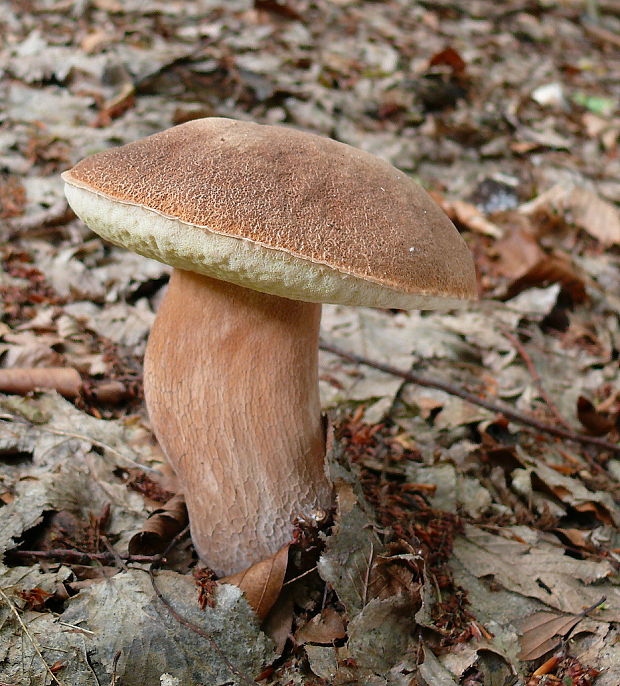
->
220 545 289 620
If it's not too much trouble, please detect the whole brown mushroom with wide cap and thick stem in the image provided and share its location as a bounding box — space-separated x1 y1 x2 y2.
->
63 118 476 574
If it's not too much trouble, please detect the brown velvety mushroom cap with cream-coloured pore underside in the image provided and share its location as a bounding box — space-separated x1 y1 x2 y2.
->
63 117 477 308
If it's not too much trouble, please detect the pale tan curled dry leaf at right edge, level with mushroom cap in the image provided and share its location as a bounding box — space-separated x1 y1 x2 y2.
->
521 184 620 246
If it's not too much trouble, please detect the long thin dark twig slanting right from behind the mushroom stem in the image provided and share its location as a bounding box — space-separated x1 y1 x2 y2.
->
319 342 620 455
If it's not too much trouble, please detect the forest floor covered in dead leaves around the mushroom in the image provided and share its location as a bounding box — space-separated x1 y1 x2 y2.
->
0 0 620 686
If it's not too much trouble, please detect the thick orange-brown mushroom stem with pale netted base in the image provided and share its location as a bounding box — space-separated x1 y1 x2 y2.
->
144 269 331 575
